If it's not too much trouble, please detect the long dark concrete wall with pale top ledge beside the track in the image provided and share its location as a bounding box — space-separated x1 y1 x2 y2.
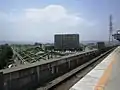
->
0 47 112 90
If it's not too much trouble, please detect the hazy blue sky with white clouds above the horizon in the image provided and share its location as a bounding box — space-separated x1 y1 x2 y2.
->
0 0 120 42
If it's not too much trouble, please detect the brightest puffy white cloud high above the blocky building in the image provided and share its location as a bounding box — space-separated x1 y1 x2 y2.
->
25 5 67 22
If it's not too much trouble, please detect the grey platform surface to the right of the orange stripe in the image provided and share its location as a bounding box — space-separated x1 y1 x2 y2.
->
105 47 120 90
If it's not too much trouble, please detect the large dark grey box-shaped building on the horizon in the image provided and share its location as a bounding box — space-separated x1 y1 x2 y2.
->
54 34 79 49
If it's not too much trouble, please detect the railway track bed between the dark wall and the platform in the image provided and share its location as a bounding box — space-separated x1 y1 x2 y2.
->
36 49 113 90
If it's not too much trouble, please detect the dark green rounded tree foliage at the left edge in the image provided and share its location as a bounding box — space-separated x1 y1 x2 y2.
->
0 44 13 69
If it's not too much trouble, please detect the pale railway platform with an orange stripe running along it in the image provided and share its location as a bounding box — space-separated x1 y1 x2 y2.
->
69 46 120 90
